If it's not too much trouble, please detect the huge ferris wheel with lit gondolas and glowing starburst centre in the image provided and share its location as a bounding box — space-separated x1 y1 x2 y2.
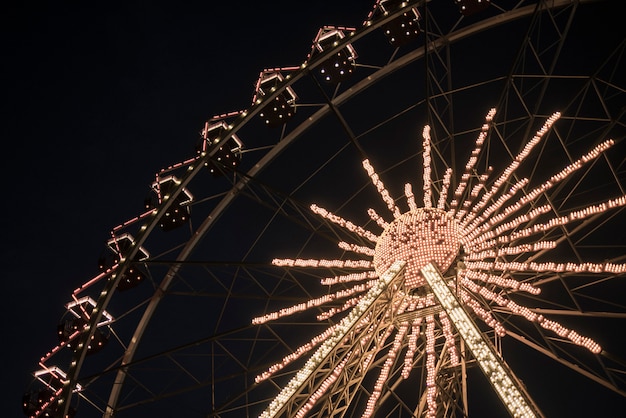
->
24 0 626 418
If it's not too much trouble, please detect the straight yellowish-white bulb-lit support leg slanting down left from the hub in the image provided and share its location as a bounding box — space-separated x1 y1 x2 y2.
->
259 261 406 418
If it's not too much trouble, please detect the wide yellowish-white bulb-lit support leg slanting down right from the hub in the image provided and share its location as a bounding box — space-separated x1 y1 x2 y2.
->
421 263 540 417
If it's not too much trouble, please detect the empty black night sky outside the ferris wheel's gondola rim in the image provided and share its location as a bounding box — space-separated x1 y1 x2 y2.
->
0 0 626 417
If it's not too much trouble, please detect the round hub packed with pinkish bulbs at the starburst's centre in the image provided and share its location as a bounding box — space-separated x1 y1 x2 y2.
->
374 208 461 289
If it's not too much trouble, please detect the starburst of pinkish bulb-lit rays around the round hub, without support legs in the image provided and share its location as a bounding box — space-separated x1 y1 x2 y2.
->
252 109 626 417
